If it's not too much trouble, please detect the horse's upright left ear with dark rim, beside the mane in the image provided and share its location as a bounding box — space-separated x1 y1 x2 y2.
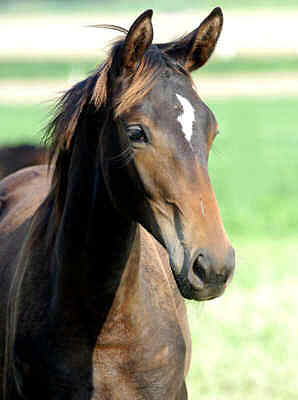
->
122 10 153 70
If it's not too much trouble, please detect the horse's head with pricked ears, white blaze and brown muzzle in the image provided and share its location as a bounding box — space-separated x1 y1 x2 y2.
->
98 8 234 300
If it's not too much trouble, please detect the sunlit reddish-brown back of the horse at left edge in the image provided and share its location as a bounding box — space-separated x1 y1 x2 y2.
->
0 166 50 318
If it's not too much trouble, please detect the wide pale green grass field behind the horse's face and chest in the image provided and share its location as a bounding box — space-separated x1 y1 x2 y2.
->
0 98 298 400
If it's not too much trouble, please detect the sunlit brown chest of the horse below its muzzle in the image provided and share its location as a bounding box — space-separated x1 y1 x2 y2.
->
92 233 189 400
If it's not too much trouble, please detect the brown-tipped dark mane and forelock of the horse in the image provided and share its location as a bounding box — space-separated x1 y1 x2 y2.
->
44 40 182 225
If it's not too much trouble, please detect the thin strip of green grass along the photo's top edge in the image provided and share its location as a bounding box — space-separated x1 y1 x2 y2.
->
0 0 298 14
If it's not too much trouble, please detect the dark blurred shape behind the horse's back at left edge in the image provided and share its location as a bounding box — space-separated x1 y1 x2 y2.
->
0 144 47 180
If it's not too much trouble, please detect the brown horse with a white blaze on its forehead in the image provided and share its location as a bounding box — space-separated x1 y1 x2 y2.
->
0 8 234 400
